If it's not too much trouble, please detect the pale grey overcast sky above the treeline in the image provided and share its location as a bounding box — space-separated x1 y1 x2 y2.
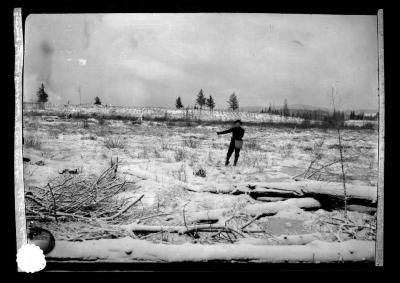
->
24 14 378 109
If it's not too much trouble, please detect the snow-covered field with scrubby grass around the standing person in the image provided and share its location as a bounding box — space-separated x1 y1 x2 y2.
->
23 113 378 260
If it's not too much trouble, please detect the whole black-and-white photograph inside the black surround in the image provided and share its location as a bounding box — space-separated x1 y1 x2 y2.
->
16 10 384 271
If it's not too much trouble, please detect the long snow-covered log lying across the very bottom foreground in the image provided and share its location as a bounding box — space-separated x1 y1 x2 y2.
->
46 237 375 263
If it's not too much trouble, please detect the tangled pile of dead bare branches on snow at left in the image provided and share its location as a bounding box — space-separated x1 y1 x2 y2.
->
25 164 143 224
